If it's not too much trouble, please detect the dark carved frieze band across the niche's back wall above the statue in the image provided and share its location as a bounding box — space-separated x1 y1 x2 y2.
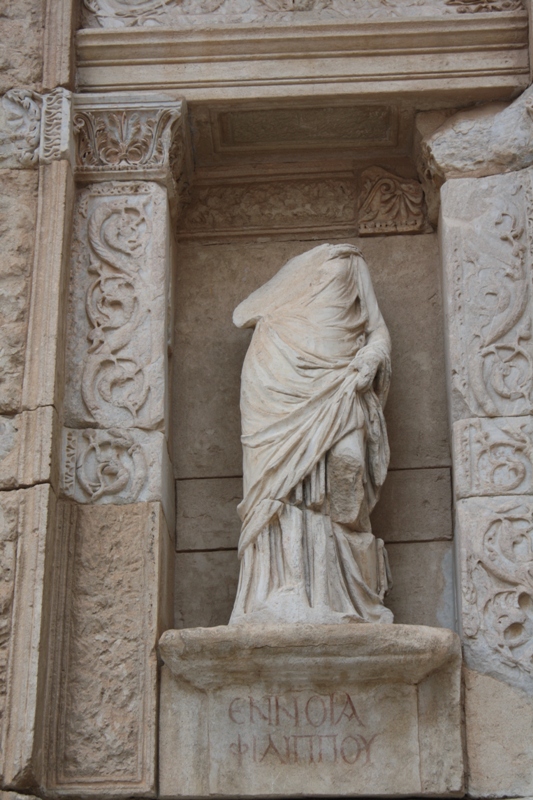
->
178 167 432 238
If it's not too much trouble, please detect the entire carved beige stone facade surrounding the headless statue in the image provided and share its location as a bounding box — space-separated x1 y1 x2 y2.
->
0 0 533 800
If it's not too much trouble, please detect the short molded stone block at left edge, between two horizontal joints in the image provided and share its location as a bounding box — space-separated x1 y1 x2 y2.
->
0 406 60 492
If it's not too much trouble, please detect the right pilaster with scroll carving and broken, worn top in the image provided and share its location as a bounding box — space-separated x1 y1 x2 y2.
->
423 84 533 796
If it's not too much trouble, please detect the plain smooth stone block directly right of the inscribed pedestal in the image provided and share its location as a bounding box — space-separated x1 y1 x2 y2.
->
464 668 533 797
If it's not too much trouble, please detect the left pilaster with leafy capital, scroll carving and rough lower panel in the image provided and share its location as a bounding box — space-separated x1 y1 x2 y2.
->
40 93 187 797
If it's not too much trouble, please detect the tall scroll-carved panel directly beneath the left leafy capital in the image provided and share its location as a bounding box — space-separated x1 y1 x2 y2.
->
65 182 169 430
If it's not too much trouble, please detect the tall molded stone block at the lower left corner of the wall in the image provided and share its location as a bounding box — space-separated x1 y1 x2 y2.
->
0 484 56 791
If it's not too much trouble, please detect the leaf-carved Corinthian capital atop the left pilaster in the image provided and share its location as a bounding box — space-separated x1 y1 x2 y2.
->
73 92 189 209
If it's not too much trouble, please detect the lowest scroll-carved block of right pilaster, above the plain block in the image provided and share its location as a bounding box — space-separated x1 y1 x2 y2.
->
457 495 533 694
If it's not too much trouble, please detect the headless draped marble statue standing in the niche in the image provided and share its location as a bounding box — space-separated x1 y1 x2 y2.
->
230 244 393 624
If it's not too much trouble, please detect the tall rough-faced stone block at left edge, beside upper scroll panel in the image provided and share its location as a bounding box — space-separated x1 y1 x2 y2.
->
0 170 38 413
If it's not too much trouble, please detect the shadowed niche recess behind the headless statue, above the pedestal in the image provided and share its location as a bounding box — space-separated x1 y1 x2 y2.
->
172 119 455 628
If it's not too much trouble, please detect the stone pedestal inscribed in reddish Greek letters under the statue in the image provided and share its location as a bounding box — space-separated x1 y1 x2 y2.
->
159 624 463 798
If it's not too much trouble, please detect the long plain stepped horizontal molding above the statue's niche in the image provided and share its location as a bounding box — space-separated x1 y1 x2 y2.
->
77 12 529 105
